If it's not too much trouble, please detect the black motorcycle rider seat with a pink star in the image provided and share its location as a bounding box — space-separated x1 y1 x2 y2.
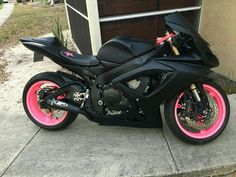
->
60 49 99 66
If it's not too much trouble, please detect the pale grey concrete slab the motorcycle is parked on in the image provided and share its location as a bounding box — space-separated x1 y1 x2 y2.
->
0 95 236 177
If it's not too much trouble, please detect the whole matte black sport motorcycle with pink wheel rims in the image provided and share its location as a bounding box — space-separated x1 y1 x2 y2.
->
21 13 230 144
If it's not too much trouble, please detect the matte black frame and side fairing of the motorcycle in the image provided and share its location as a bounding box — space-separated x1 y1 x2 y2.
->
87 52 209 127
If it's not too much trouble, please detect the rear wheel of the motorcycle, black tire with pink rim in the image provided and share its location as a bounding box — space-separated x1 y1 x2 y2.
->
22 72 78 130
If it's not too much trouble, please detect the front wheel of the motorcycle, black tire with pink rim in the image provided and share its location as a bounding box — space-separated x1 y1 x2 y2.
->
165 81 230 144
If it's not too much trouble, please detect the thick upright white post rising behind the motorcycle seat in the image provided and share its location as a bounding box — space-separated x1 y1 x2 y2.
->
86 0 102 55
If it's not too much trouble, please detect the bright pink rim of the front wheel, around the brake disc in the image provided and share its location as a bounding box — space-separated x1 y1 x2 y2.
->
175 84 226 139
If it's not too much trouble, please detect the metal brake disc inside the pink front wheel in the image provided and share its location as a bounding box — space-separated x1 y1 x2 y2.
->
178 93 218 131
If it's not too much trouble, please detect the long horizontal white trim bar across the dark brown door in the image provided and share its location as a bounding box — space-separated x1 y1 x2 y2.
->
99 6 201 22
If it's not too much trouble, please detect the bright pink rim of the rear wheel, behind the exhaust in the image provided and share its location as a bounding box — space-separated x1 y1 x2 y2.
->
26 81 68 126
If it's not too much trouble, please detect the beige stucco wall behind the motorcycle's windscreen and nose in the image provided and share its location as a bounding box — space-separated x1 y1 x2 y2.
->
200 0 236 80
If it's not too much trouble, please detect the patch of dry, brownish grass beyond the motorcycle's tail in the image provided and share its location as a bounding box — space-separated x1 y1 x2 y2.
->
0 4 68 48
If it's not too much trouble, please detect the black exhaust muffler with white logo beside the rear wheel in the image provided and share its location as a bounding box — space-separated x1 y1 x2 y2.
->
46 99 80 113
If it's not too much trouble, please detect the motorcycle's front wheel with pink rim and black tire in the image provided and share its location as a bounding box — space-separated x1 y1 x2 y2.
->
165 82 229 144
